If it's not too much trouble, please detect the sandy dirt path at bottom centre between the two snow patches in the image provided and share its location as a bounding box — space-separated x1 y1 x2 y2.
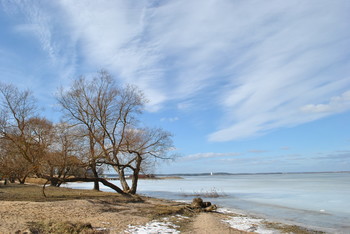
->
189 213 249 234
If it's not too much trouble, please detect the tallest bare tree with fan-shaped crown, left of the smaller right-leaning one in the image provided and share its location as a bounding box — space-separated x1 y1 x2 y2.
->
58 71 145 192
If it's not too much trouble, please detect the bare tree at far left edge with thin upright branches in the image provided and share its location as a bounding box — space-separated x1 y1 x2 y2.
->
0 84 43 183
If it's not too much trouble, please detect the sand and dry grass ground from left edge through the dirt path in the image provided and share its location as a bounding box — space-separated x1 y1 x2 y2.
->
0 185 252 233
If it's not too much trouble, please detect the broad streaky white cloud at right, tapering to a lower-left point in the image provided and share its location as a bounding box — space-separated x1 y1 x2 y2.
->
209 1 350 141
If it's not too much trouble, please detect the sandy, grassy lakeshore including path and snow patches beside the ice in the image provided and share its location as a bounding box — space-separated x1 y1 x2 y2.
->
0 185 334 234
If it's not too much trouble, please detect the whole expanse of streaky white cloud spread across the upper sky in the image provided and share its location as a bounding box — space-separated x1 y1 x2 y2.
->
1 0 350 141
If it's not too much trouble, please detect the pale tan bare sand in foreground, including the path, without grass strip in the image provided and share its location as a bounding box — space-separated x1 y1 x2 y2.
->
0 199 248 234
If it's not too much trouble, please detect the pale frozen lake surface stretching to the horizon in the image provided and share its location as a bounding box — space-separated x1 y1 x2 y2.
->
64 173 350 233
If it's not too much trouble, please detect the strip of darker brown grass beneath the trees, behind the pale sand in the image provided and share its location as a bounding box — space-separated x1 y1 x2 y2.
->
0 184 186 218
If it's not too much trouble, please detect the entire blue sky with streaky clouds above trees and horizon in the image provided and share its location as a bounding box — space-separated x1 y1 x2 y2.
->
0 0 350 173
